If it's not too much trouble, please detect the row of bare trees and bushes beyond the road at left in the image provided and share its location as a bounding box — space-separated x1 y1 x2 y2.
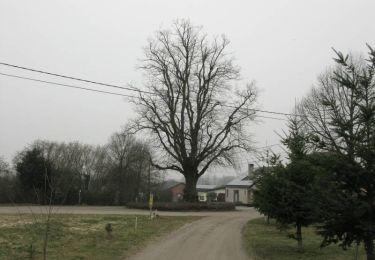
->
0 127 160 205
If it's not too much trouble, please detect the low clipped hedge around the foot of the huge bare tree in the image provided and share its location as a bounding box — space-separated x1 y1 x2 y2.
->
126 202 235 211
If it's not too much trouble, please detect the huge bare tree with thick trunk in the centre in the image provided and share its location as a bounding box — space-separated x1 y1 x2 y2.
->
135 20 256 201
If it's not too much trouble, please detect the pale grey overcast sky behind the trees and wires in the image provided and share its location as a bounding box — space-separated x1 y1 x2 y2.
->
0 0 375 175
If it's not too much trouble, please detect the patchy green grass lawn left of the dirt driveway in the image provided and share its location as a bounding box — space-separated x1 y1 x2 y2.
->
0 214 197 260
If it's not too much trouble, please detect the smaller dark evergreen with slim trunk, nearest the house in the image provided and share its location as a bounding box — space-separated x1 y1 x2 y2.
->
254 118 317 251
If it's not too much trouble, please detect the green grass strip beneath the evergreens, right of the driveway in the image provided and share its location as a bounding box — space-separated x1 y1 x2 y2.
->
243 218 366 260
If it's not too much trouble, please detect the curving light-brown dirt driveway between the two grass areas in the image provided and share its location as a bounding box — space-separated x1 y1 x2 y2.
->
128 210 259 260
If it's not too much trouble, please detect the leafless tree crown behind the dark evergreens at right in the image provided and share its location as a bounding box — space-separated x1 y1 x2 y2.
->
298 67 360 160
